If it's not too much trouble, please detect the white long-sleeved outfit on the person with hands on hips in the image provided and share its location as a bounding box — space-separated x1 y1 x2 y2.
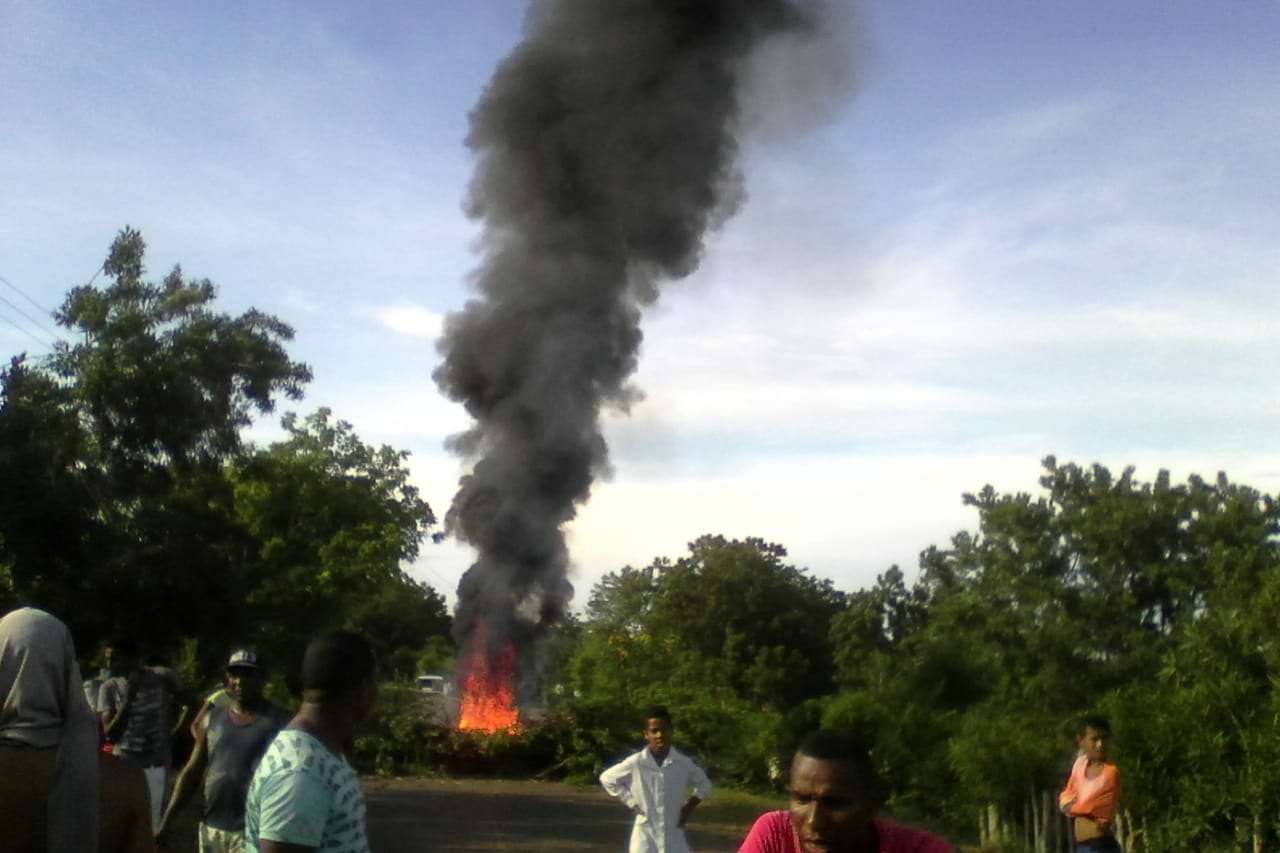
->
600 747 712 853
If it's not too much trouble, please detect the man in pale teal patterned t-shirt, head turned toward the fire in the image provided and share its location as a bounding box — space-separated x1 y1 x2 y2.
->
244 631 378 853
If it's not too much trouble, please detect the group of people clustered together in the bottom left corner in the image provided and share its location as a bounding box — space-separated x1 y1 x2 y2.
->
0 607 378 853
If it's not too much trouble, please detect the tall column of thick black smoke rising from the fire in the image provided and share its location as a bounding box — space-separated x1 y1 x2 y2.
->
435 0 844 691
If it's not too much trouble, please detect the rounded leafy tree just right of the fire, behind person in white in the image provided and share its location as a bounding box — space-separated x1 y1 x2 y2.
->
566 535 842 781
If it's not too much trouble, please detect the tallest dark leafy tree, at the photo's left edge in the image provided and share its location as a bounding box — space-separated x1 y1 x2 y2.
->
0 228 311 644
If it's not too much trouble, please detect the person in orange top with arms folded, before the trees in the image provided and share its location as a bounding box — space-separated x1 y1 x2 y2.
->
1057 716 1121 853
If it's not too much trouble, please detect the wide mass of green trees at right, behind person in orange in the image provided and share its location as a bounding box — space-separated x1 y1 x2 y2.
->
824 457 1280 850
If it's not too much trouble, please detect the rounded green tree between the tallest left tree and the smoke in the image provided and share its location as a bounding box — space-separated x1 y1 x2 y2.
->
229 409 448 666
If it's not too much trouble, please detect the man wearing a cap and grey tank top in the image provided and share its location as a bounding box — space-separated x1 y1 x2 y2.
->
156 648 289 853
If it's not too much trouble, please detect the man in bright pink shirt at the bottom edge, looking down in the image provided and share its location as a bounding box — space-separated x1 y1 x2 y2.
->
739 730 955 853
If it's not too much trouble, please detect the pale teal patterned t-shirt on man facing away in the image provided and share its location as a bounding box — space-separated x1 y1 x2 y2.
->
244 729 369 853
